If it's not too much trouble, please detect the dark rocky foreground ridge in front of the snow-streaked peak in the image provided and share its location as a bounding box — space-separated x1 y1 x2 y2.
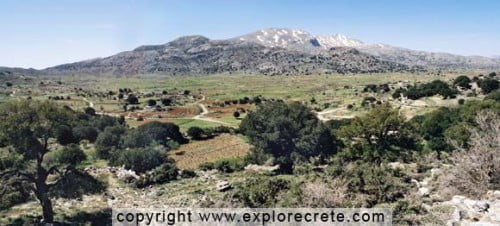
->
43 34 421 75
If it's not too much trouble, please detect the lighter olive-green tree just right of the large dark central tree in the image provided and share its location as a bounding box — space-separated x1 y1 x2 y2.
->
338 104 417 162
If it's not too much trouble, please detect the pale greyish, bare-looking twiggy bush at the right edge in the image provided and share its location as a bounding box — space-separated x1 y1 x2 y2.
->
438 111 500 199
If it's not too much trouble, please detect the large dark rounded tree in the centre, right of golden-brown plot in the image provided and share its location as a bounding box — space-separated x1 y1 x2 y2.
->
240 102 336 172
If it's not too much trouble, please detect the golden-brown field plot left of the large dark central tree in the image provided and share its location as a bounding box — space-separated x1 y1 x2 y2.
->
170 134 250 169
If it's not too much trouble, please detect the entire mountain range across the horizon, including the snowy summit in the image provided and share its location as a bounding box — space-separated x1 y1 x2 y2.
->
0 28 500 75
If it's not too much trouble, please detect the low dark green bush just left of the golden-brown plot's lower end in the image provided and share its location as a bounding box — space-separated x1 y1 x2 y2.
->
112 147 167 174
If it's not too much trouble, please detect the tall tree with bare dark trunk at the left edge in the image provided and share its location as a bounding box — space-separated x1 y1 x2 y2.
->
0 100 86 223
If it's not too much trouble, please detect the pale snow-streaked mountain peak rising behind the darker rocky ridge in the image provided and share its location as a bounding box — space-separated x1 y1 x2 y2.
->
234 28 500 69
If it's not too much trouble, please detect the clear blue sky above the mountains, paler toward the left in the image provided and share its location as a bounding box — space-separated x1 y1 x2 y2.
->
0 0 500 68
